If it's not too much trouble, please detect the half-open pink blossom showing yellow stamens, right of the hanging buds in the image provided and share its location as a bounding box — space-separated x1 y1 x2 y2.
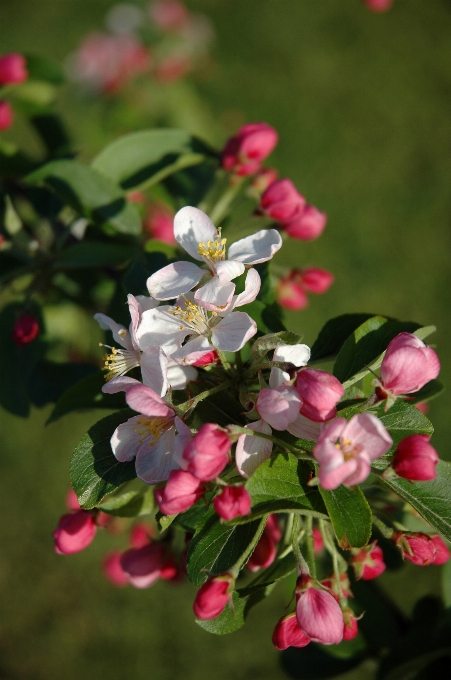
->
313 413 393 490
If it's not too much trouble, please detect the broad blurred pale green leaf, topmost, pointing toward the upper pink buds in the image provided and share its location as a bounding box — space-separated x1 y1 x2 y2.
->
92 128 215 191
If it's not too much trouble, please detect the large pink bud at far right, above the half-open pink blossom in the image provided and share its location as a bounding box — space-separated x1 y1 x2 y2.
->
381 333 440 398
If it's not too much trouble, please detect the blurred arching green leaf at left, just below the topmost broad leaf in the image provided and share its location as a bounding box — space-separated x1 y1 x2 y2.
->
26 160 141 234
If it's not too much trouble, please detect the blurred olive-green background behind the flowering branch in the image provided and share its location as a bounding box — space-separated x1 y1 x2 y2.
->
0 0 451 680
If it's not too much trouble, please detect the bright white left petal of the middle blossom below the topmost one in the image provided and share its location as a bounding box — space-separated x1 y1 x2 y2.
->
136 305 192 356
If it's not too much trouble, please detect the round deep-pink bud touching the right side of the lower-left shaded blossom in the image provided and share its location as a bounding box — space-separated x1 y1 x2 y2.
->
183 423 232 482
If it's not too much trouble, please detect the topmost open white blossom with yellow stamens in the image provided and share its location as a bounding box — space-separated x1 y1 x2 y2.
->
147 206 282 312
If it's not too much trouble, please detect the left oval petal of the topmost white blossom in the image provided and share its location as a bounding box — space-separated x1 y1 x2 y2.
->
147 262 205 300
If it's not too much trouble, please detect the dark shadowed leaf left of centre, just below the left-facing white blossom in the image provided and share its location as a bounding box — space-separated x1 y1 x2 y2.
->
47 371 124 425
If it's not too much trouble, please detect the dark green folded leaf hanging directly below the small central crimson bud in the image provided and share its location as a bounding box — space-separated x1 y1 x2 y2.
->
187 509 262 586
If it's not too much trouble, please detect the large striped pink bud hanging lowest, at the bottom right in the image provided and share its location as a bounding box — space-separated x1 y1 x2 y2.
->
296 577 343 645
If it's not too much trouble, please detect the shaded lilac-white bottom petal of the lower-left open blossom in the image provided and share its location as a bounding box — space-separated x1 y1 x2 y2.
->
136 426 178 484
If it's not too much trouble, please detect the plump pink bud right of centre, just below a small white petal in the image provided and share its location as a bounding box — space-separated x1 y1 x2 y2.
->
296 368 344 423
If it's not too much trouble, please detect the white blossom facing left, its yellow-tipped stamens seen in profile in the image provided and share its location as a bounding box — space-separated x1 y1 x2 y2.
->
94 295 197 395
